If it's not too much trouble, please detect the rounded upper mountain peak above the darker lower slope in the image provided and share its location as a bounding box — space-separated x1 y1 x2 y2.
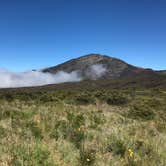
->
43 54 156 80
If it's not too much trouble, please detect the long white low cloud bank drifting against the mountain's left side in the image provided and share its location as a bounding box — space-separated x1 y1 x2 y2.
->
0 69 81 88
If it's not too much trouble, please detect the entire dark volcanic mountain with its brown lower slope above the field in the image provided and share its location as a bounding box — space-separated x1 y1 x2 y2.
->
0 54 166 91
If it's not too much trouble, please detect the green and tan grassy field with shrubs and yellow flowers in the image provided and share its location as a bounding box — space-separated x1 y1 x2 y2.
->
0 89 166 166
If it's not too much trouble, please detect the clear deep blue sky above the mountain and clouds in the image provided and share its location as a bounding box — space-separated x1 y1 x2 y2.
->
0 0 166 71
